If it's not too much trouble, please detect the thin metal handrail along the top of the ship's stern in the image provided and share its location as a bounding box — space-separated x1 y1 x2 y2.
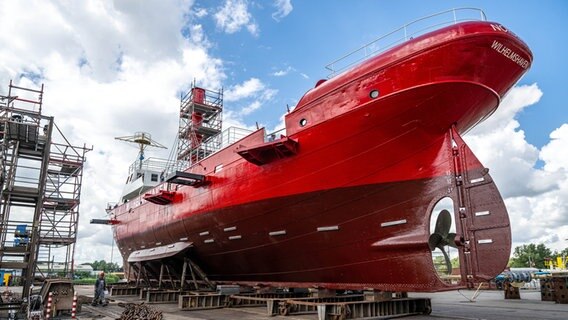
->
325 7 487 78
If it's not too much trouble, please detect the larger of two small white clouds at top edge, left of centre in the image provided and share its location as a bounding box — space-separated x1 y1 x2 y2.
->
213 0 259 36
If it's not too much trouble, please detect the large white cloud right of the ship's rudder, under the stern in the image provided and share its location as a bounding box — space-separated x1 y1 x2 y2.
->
464 84 568 254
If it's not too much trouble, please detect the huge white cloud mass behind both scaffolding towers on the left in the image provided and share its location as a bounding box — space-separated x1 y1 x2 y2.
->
0 1 230 262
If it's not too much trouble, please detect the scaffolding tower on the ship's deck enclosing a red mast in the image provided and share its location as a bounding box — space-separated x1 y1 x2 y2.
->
177 82 223 167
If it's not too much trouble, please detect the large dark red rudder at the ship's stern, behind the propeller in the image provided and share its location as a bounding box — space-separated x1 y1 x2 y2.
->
448 128 511 288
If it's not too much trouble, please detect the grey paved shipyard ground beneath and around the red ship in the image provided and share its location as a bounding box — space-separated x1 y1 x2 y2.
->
71 286 568 320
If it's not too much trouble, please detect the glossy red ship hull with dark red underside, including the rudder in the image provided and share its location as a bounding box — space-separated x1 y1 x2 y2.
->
113 22 532 291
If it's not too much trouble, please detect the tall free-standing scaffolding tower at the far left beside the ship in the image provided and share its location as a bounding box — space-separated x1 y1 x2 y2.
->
0 81 92 296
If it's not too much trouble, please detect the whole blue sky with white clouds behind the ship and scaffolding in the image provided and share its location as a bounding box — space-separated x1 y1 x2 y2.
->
0 0 568 262
